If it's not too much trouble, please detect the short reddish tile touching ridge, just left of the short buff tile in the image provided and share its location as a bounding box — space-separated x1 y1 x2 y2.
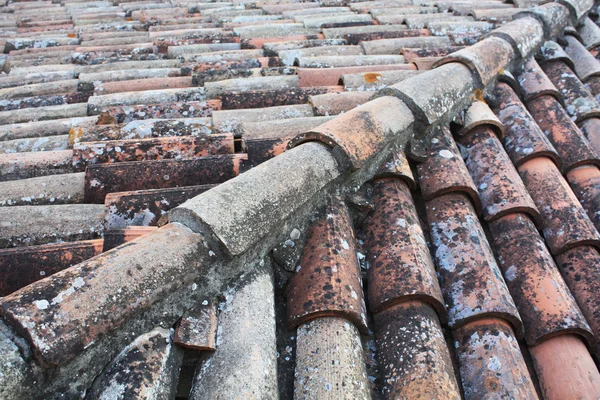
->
417 127 481 213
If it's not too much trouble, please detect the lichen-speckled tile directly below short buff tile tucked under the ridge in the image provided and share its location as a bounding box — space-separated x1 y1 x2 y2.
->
460 125 540 222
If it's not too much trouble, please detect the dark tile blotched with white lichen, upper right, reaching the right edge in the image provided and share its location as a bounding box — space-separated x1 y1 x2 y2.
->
542 61 600 124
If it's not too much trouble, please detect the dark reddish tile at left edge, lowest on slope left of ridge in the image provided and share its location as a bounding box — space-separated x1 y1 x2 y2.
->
0 239 102 297
